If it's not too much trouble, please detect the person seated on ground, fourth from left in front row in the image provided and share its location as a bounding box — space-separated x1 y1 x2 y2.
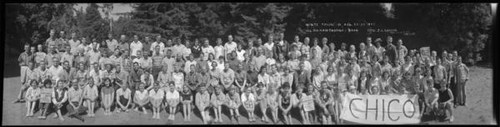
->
66 79 87 122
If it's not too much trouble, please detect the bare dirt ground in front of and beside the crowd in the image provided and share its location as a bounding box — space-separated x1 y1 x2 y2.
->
2 67 496 125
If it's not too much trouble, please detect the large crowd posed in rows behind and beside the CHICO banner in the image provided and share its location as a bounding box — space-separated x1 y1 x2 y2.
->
15 30 469 124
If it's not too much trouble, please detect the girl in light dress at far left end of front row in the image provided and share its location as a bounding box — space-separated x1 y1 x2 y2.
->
26 80 40 116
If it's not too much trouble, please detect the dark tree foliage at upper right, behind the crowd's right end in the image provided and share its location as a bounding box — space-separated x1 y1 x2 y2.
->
394 3 492 64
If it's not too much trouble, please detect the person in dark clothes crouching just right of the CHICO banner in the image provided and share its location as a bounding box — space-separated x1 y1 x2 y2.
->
437 82 454 122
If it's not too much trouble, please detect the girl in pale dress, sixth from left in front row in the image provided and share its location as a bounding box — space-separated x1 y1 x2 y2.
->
101 78 115 115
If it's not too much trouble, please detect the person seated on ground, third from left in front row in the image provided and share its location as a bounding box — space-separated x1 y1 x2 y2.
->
52 80 68 121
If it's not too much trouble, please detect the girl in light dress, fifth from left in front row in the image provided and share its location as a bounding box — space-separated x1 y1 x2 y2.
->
83 78 99 117
